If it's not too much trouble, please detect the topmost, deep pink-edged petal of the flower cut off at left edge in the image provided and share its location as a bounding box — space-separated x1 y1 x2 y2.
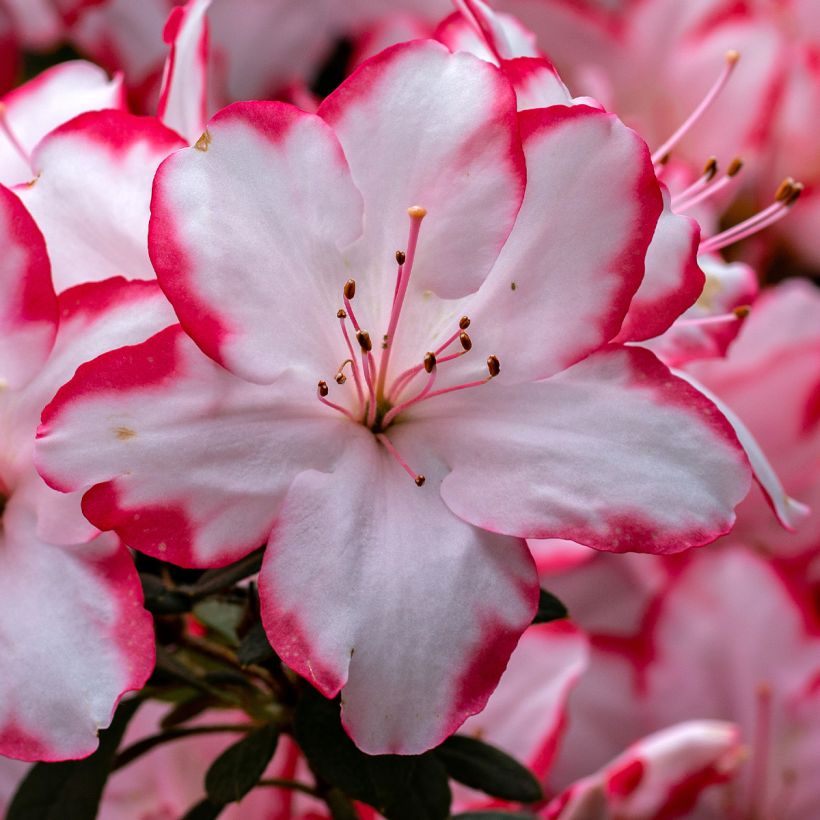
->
0 185 57 393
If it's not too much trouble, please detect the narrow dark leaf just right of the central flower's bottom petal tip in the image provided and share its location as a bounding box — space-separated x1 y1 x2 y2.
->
435 735 544 803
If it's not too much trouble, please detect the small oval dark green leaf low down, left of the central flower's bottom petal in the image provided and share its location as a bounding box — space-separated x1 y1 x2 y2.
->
205 724 279 804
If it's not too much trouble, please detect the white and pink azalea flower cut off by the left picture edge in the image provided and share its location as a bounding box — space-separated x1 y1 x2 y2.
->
0 181 173 760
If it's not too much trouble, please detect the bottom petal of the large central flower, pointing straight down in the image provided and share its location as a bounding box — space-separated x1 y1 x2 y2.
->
259 436 538 754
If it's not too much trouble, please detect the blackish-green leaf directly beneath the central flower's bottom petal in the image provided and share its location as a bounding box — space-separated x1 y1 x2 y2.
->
294 685 451 820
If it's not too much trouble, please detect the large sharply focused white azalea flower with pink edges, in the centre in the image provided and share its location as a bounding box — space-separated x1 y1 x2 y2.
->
39 41 749 753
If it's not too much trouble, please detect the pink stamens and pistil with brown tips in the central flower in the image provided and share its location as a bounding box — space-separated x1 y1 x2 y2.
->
317 205 501 487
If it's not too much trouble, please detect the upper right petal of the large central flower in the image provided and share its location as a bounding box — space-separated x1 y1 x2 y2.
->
454 106 661 381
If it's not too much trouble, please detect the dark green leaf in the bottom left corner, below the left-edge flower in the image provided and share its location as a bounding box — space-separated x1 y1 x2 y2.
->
6 698 141 820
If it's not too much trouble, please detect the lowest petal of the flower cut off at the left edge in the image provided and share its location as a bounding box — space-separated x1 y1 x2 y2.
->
0 494 154 760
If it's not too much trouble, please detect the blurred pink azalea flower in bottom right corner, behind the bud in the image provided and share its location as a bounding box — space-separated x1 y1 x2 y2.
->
551 536 820 820
